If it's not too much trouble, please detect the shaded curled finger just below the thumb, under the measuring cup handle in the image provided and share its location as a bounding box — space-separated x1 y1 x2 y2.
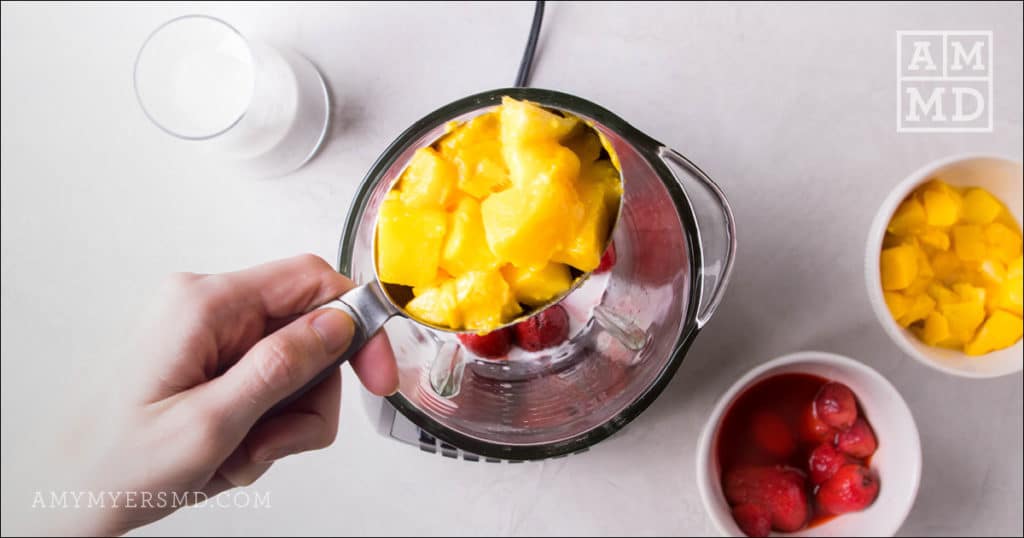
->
246 370 341 462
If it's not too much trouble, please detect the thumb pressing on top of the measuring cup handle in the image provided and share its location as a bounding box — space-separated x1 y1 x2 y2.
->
197 308 354 434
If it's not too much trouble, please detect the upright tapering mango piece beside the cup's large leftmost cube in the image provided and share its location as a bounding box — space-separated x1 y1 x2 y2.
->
440 197 501 277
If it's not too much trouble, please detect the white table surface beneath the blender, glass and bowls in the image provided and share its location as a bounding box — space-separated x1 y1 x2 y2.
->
2 3 1024 536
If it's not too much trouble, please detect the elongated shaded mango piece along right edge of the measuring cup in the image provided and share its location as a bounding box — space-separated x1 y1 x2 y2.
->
551 161 622 273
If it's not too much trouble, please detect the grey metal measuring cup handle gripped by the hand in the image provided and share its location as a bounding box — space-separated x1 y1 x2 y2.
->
263 282 395 418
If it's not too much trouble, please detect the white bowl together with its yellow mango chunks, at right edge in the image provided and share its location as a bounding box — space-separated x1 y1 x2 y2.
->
865 155 1024 378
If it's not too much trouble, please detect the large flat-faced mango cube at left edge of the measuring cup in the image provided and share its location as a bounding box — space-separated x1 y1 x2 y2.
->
377 194 447 286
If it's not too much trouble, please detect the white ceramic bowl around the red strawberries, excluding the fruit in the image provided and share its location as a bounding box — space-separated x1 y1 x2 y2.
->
696 351 921 536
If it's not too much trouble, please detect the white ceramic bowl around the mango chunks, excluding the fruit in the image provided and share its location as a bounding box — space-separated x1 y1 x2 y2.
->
864 155 1024 378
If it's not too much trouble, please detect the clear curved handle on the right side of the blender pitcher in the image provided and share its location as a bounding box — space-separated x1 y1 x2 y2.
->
657 146 736 329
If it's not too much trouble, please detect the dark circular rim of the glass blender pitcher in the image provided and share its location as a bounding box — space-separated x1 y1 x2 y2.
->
338 88 703 460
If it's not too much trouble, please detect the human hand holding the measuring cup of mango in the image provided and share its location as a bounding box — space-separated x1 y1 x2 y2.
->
58 255 398 534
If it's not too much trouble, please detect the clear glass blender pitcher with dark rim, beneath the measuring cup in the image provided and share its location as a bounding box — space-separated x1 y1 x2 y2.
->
338 88 735 460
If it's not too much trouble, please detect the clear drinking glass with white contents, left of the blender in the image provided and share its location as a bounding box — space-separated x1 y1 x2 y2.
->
134 15 330 175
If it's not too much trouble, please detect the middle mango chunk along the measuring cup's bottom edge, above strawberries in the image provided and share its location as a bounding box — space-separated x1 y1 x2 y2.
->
455 270 522 331
